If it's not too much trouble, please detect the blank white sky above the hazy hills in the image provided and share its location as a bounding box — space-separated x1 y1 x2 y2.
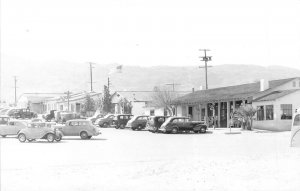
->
1 0 300 69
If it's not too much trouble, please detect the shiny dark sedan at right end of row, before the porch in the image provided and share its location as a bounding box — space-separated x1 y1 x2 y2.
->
159 117 207 134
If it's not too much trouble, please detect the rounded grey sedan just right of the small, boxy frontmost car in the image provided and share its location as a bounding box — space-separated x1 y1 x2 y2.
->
55 119 101 139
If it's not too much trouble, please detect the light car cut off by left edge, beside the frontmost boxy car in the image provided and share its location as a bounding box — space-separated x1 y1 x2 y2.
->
0 117 27 137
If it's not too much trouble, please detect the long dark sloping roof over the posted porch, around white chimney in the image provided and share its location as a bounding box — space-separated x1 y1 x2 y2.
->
174 78 296 105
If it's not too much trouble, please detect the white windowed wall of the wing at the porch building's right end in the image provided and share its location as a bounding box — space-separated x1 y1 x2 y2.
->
252 91 300 131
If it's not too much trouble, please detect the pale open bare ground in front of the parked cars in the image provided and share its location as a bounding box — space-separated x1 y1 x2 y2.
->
0 128 300 191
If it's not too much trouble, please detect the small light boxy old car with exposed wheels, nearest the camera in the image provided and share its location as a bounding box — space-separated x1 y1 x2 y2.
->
18 122 63 142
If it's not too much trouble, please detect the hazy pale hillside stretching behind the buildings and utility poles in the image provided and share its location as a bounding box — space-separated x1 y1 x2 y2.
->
1 54 300 103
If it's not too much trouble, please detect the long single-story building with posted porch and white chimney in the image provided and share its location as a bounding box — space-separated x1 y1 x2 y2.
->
174 77 300 130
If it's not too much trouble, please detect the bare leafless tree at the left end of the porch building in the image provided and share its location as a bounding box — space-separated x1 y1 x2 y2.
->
151 87 176 116
